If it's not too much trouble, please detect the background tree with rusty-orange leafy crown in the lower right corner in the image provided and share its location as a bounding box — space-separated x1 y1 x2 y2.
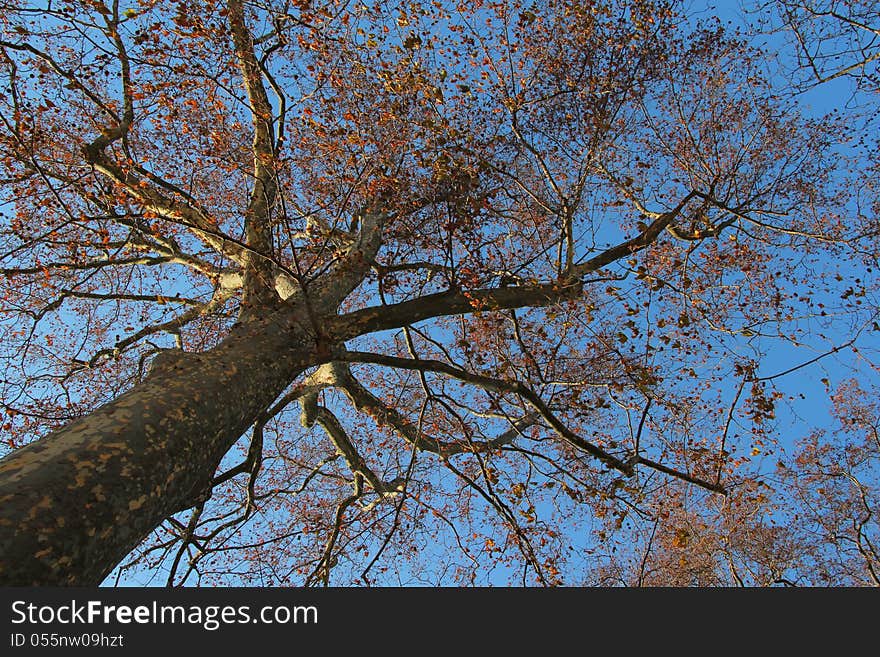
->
595 380 880 586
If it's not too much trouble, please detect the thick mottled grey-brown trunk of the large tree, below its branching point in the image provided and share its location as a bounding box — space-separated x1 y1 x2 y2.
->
0 306 321 586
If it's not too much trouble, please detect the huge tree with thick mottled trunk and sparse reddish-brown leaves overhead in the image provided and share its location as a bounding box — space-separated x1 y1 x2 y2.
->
0 0 877 584
